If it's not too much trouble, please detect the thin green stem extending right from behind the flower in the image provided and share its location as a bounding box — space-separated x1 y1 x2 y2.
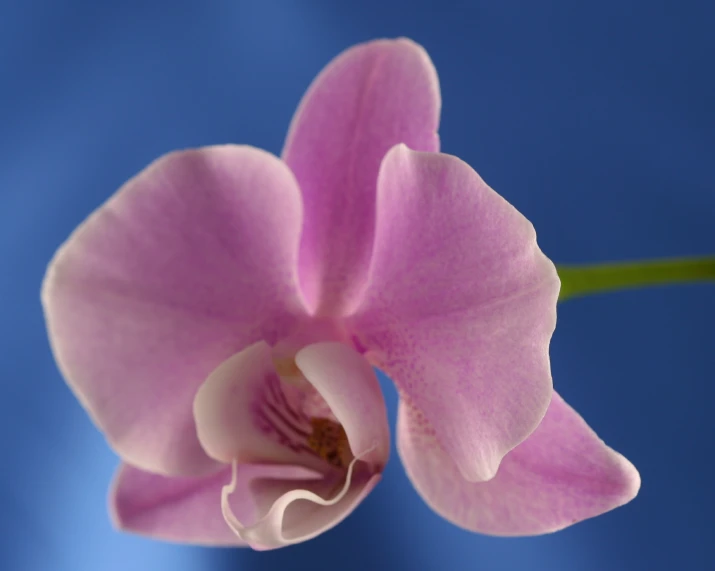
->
557 257 715 302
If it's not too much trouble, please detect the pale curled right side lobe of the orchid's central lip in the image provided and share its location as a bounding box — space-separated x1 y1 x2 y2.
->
295 342 390 471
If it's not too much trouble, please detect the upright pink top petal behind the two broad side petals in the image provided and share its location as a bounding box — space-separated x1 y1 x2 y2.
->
283 38 441 314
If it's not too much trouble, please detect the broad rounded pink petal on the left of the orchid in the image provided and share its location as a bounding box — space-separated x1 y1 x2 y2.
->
42 146 303 476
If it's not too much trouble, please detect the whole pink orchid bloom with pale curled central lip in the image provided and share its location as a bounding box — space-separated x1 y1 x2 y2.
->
42 39 639 549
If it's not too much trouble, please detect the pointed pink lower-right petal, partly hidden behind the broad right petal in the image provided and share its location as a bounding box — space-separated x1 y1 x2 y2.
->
397 393 640 536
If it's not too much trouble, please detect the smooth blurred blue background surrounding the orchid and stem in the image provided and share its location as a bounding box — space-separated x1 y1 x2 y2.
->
0 0 715 571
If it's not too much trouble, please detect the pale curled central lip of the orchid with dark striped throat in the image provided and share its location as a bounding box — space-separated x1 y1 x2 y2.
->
194 337 389 549
